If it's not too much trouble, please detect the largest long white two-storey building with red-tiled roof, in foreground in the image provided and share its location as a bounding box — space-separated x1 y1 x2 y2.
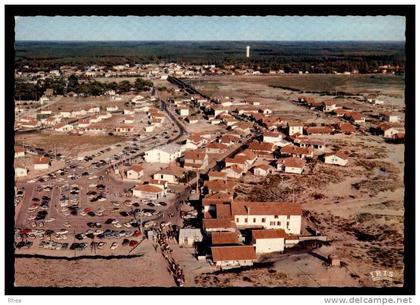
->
231 201 302 235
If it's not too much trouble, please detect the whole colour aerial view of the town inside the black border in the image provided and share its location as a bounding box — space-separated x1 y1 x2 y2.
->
9 16 406 289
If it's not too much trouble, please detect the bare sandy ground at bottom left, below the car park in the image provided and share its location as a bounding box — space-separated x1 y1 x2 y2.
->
15 240 175 287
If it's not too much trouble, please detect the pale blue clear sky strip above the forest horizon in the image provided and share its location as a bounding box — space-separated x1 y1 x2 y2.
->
15 16 405 41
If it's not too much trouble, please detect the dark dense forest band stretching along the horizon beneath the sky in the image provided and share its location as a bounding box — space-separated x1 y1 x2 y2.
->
15 42 405 73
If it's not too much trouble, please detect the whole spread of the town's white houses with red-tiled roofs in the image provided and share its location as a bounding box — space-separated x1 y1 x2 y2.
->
15 59 405 274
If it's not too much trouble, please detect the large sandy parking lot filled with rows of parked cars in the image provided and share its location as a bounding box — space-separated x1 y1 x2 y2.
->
15 101 187 256
